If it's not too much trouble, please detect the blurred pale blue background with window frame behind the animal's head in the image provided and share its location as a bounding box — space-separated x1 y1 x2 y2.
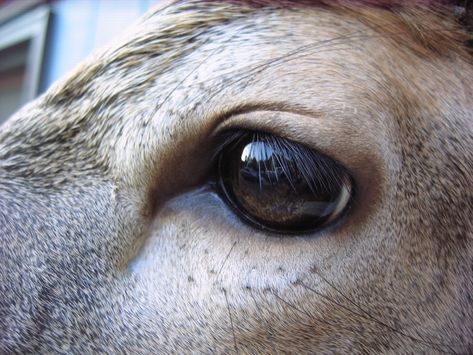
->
0 0 162 125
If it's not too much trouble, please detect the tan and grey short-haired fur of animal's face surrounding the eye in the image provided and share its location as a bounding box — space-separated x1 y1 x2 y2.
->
0 0 473 354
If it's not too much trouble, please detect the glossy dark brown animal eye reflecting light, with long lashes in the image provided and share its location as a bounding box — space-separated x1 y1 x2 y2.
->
218 131 353 234
